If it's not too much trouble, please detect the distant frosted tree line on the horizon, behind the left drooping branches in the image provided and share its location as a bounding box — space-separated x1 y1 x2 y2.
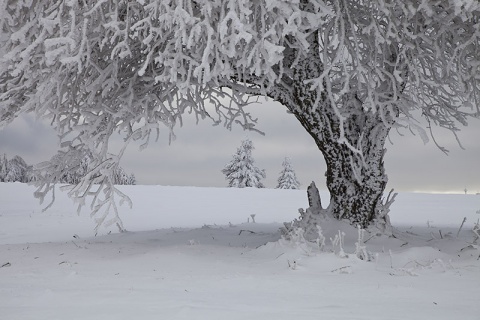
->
0 154 136 185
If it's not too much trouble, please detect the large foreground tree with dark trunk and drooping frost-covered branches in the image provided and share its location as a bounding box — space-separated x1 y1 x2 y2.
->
0 0 480 227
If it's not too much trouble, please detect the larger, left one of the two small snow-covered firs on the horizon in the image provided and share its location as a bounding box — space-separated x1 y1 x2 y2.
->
222 139 266 188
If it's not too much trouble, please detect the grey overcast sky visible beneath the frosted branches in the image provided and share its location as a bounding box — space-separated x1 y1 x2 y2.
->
0 101 480 193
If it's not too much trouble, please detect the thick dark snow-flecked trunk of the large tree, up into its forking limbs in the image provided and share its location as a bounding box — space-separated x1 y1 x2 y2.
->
269 31 396 229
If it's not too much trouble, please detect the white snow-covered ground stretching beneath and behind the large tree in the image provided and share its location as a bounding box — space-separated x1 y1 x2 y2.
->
0 183 480 320
